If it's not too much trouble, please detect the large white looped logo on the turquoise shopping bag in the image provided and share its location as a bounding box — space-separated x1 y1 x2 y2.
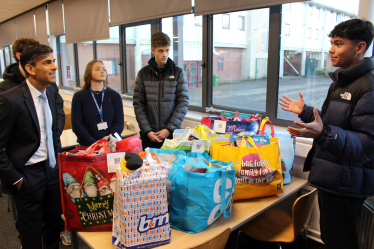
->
208 178 235 225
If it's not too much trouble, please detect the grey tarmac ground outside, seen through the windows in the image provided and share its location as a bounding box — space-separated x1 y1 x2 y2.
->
189 76 332 120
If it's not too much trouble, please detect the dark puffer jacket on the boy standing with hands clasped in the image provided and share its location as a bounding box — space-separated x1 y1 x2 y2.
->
133 58 189 135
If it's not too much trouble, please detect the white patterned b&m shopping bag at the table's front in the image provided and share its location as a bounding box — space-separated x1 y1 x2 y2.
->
112 159 171 249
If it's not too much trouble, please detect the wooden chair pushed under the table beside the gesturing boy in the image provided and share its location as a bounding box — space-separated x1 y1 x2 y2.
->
236 189 317 247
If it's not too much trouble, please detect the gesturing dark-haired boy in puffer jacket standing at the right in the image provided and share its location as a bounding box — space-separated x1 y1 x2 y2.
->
279 19 374 249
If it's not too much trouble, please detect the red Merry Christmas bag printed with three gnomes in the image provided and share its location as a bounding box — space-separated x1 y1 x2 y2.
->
59 142 117 232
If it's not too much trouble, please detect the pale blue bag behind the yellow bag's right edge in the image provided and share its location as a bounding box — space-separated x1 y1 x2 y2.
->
257 118 296 184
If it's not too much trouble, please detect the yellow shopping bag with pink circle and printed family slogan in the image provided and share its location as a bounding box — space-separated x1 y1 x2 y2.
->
212 135 283 200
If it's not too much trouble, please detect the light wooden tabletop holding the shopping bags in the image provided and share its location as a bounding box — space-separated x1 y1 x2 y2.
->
72 177 307 249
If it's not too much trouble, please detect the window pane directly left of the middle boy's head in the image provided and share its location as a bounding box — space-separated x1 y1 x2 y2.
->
126 24 152 94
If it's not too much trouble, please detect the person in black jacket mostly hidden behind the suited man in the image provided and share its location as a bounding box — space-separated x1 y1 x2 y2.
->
0 37 65 136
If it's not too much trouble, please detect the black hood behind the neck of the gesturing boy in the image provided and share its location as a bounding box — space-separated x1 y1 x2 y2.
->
329 57 374 86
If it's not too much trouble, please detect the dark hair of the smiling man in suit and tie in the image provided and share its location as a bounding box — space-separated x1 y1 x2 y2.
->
20 45 53 78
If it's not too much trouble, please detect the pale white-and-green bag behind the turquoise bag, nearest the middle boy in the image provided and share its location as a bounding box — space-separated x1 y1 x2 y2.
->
161 128 211 153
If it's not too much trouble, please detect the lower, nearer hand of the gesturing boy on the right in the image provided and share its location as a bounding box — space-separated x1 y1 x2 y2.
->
287 107 323 139
